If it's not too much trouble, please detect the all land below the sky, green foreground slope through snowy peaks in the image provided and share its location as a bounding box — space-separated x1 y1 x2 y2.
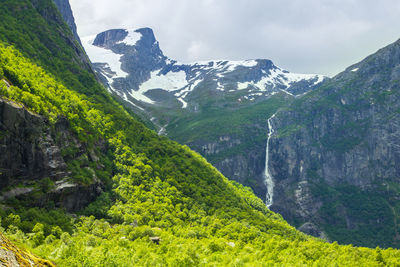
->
0 0 400 266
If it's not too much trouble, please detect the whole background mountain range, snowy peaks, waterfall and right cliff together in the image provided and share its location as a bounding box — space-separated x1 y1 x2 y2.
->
84 25 399 247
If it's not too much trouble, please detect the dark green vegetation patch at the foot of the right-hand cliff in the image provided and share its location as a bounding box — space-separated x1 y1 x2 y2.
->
313 181 397 247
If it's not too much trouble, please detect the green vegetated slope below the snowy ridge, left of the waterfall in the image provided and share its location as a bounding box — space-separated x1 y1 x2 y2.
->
167 91 293 192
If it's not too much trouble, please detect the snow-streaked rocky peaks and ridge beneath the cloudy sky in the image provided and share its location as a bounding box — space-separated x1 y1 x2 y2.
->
83 28 326 109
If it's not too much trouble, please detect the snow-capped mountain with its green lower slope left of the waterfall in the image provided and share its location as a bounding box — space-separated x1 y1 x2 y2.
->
83 28 327 199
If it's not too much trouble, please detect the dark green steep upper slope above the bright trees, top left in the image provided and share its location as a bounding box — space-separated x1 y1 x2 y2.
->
0 0 98 98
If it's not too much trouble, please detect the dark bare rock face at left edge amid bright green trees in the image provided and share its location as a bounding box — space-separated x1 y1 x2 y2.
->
0 99 102 211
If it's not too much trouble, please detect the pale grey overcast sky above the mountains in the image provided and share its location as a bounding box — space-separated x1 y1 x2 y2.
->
70 0 400 76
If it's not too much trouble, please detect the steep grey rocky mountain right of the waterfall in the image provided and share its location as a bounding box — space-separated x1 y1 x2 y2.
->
269 38 400 247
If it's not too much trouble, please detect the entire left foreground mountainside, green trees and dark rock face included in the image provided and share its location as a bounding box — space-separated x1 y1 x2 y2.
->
0 0 400 266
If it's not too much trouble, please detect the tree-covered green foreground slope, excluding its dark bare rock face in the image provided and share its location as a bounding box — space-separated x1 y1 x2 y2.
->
0 0 400 266
